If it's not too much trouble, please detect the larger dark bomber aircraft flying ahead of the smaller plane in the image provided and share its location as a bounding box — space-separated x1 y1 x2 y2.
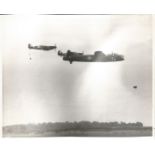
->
58 50 124 64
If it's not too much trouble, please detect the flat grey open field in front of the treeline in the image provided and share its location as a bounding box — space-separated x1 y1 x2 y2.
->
3 127 152 137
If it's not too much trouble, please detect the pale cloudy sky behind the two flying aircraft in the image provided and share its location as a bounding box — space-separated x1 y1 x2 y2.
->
0 15 152 125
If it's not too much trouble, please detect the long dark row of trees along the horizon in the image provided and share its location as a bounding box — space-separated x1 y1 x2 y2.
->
3 121 143 133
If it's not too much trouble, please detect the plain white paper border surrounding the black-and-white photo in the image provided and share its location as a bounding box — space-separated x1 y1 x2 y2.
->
0 0 155 155
